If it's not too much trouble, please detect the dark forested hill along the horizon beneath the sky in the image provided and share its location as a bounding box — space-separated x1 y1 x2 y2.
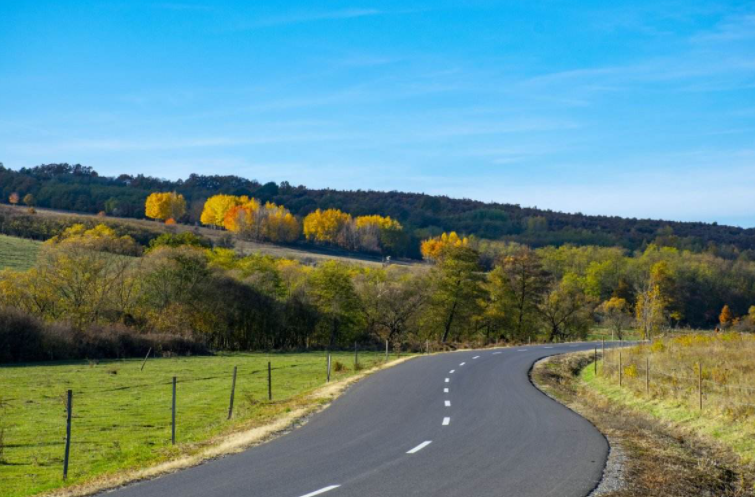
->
0 164 755 259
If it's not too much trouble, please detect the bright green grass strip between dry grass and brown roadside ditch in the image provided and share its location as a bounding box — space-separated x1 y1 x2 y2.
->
580 358 755 463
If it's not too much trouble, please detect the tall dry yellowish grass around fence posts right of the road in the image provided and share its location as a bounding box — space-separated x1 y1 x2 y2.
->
598 332 755 420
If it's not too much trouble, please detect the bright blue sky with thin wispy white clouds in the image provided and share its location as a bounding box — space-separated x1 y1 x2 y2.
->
0 0 755 227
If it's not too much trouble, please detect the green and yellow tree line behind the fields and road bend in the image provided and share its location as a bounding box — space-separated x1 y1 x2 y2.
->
0 225 755 359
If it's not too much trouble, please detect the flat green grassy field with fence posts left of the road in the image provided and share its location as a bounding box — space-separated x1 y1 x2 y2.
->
0 353 398 497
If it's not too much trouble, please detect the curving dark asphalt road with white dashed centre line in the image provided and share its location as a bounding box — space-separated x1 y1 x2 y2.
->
112 344 624 497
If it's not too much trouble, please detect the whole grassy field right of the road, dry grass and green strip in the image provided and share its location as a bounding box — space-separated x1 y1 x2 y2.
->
581 333 755 463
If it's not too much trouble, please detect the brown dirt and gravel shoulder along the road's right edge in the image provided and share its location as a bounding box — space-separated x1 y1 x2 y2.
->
532 353 755 497
